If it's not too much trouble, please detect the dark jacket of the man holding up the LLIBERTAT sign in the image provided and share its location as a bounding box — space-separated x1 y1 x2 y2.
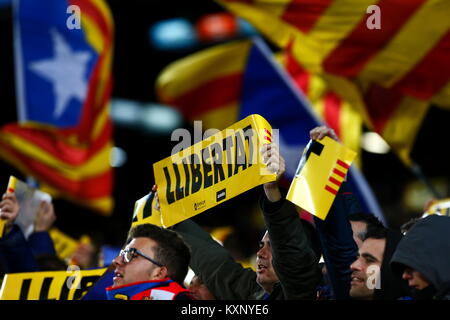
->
174 195 321 300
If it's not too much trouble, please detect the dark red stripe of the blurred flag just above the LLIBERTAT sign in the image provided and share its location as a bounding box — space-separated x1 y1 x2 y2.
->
162 72 242 119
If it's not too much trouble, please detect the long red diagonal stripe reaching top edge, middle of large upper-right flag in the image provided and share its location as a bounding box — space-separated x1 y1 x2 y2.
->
323 0 426 77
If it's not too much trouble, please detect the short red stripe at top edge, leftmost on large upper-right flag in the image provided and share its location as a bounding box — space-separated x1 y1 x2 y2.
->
281 0 333 33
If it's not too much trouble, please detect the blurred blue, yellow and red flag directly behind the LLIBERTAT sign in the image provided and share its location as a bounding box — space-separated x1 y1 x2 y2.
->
156 39 384 220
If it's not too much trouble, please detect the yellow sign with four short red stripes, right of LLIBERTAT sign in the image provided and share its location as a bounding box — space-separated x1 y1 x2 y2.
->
286 137 356 220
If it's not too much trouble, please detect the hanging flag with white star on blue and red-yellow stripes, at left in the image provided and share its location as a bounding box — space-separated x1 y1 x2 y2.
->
0 0 113 214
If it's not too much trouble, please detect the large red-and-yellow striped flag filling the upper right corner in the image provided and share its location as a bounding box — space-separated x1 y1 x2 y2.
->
218 0 450 165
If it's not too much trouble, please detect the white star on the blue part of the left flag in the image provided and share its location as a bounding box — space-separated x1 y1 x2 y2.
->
29 29 91 118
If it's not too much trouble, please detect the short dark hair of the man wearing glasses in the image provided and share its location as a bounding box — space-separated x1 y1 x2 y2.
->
127 223 191 285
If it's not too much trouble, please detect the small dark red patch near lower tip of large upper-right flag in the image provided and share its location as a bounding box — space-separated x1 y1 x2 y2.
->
364 85 404 135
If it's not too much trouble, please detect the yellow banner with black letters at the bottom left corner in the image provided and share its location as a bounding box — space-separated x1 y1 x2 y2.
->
0 268 106 300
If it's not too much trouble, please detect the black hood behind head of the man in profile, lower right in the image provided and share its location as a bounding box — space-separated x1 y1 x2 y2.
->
374 230 410 300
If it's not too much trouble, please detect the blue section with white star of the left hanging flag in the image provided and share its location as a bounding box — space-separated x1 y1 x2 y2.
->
14 0 98 128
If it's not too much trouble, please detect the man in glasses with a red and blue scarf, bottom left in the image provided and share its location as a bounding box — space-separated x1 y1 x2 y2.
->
106 224 192 300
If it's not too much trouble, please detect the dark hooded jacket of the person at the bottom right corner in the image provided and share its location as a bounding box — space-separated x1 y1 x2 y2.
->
391 215 450 300
